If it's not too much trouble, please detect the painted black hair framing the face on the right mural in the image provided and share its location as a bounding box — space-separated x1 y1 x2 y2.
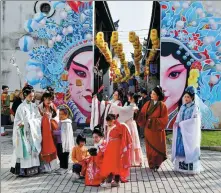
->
161 42 192 108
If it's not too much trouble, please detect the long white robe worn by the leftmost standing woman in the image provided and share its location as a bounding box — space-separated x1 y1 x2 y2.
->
11 100 42 168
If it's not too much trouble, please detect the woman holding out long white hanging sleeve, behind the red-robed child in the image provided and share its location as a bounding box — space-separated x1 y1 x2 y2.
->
90 90 123 138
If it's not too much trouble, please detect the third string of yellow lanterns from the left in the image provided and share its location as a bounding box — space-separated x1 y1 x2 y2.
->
129 31 142 77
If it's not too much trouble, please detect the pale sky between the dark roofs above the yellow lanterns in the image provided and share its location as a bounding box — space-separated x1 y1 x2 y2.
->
108 1 153 61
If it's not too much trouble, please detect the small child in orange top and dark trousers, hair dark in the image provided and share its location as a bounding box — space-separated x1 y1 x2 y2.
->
72 134 90 178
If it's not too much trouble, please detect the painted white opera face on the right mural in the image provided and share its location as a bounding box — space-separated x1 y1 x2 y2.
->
160 55 187 113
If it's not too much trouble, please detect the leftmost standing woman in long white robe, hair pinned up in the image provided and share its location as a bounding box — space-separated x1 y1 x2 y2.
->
10 85 42 176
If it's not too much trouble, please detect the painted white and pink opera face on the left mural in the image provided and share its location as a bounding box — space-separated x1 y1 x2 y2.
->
68 51 93 117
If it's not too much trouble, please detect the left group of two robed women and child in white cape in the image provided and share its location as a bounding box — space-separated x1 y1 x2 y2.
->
10 85 74 176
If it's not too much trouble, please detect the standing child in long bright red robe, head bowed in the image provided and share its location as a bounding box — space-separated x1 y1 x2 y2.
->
101 114 132 188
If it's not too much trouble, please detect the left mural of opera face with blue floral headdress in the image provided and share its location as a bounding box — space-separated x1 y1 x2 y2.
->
19 1 93 124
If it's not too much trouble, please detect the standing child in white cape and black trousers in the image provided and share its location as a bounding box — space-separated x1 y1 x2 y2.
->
53 105 74 174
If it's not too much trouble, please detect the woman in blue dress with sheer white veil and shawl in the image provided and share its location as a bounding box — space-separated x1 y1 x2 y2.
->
172 86 202 174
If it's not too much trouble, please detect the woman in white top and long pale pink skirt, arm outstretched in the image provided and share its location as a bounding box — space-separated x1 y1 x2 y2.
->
112 93 143 166
